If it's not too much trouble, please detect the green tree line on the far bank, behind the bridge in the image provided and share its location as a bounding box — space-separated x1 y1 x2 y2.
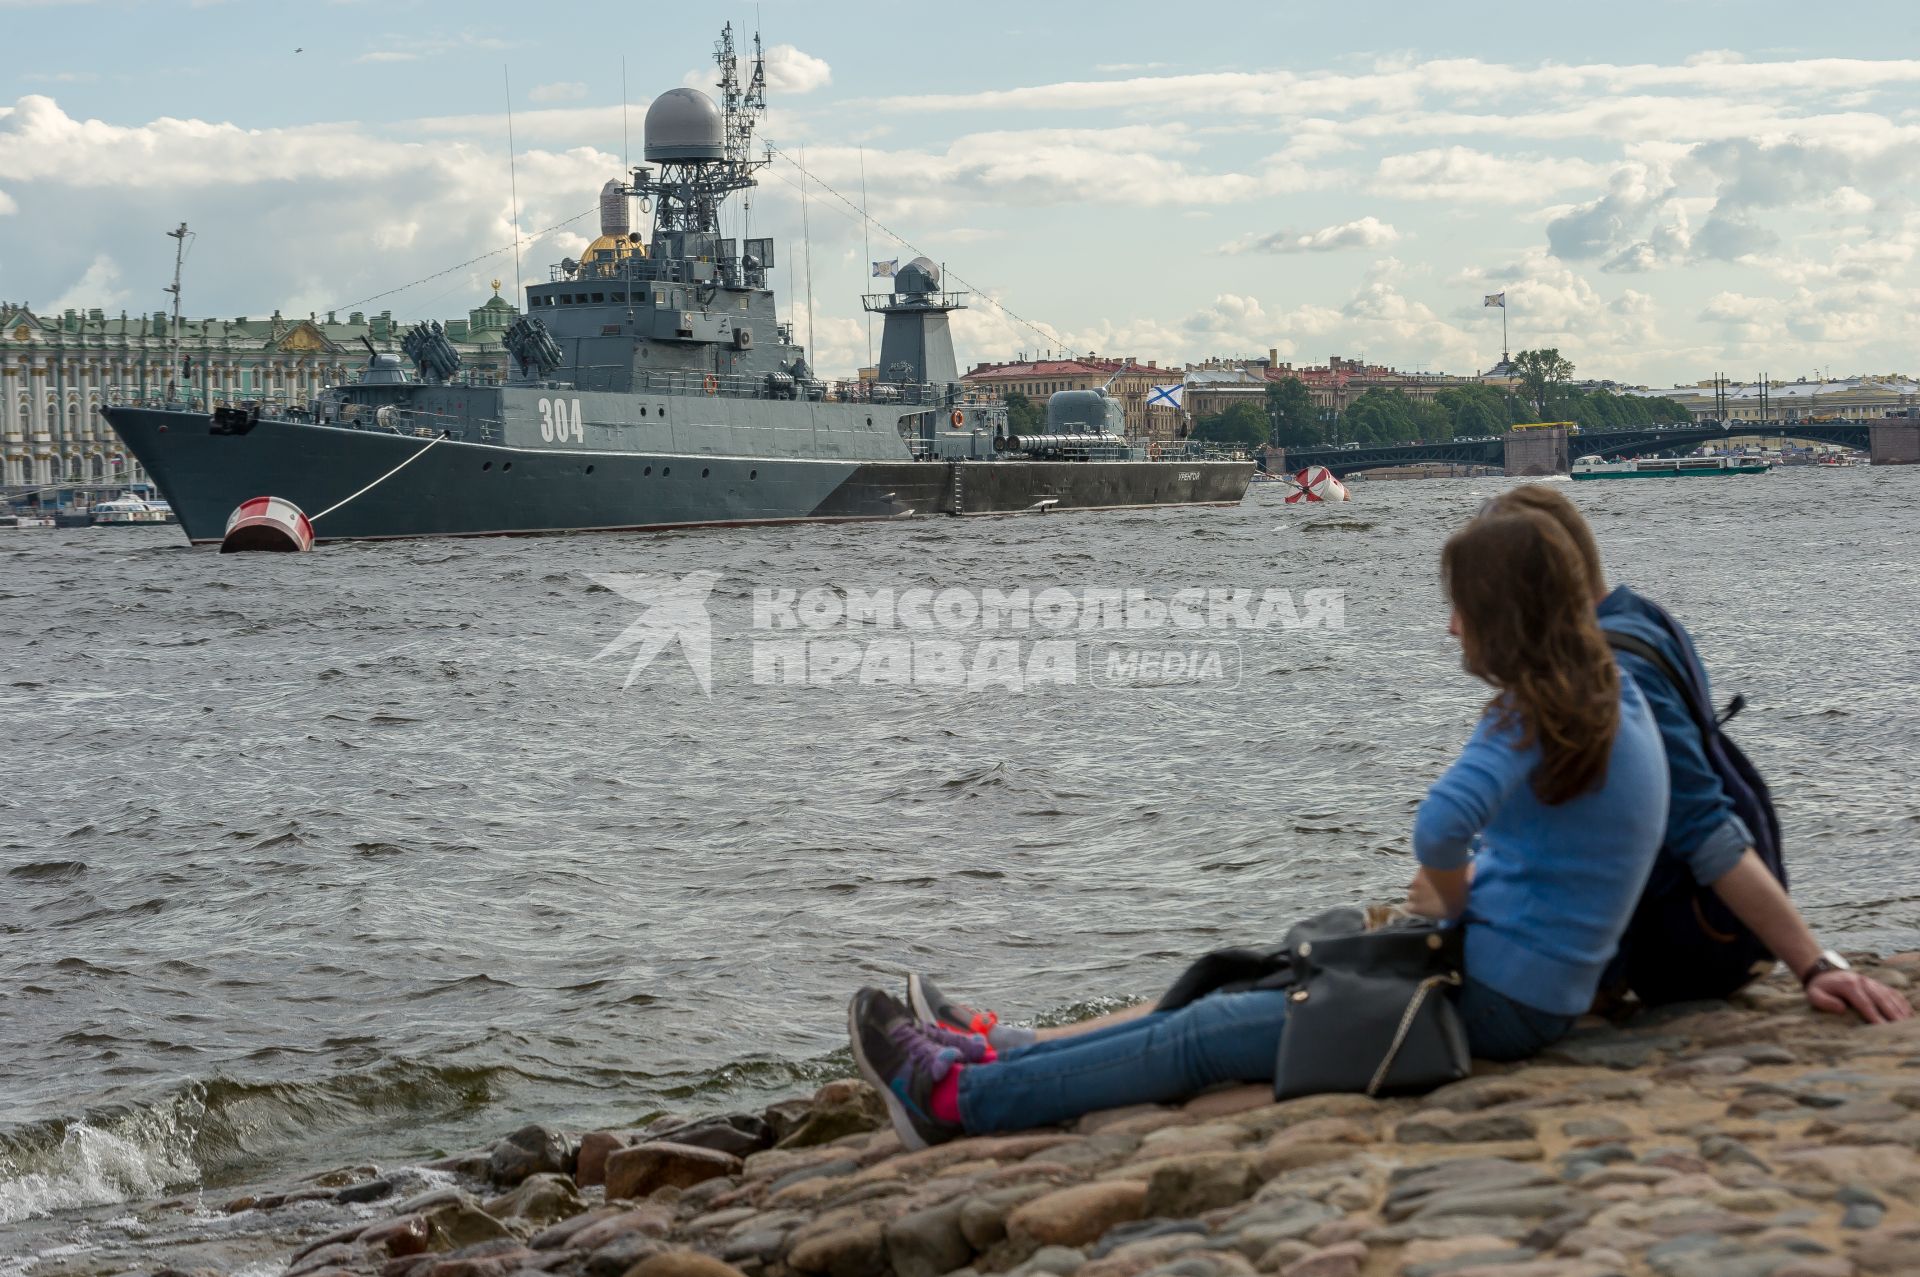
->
1194 349 1693 447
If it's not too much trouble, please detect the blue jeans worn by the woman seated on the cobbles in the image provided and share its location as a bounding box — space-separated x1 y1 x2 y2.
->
960 976 1574 1135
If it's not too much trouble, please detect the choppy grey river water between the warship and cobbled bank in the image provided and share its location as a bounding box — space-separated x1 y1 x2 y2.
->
0 469 1920 1271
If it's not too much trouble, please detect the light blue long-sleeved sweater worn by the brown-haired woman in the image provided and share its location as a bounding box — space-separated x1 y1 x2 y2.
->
1413 674 1667 1016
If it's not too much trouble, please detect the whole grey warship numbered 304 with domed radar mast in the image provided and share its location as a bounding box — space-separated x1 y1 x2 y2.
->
102 29 1254 543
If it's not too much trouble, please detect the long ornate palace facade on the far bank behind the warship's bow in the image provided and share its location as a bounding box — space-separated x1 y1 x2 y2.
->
0 284 518 488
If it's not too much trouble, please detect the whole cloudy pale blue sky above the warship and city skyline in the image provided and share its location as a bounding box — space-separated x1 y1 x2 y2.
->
0 0 1920 384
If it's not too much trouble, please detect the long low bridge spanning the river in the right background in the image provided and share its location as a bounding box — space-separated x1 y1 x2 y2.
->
1267 417 1920 474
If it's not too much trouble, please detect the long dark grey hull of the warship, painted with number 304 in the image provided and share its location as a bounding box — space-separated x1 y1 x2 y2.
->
106 407 1254 543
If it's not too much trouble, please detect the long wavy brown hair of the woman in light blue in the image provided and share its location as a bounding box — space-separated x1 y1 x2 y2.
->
1440 509 1620 807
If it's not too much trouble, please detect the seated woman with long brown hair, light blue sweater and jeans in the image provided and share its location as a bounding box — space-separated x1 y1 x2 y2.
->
847 509 1667 1148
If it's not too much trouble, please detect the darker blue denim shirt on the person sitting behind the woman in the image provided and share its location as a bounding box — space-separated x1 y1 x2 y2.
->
1599 586 1753 885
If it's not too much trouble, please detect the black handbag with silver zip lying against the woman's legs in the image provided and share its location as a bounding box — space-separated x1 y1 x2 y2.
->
1273 908 1473 1100
